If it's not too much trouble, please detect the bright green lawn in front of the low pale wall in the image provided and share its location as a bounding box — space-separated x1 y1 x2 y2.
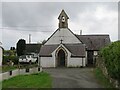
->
2 72 52 88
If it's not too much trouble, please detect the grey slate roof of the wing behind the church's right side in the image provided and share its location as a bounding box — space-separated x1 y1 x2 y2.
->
76 35 110 50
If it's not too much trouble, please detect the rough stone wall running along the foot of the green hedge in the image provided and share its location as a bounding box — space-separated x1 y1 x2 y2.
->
96 57 120 88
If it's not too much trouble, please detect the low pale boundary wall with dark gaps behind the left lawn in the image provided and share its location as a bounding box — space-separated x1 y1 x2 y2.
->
0 67 42 81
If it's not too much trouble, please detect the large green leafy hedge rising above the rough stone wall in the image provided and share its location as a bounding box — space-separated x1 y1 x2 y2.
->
100 41 120 82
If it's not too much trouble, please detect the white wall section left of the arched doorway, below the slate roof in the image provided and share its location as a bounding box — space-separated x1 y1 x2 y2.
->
40 57 55 67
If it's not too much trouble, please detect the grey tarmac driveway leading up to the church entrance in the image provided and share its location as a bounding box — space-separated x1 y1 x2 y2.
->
43 68 102 88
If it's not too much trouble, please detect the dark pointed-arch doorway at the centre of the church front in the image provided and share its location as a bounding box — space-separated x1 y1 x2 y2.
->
58 49 65 67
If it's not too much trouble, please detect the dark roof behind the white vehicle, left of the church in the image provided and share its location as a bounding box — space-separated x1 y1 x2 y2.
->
26 44 41 53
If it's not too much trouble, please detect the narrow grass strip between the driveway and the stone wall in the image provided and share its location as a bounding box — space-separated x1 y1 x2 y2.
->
94 68 114 88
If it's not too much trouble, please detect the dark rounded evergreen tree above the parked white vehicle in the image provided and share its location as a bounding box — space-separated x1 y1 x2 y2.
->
16 39 26 56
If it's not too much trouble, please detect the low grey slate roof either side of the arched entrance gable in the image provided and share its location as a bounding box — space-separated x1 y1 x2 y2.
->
39 44 85 57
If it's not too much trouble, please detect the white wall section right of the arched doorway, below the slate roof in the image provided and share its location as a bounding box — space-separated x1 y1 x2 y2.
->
68 58 86 67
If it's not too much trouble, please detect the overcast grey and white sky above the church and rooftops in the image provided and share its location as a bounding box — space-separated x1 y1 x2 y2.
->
0 2 118 49
